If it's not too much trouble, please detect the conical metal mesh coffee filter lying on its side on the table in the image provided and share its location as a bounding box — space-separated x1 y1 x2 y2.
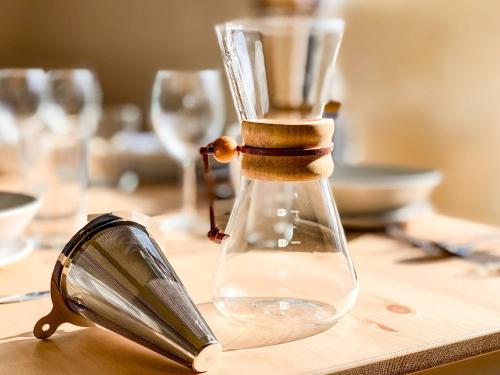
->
34 214 221 372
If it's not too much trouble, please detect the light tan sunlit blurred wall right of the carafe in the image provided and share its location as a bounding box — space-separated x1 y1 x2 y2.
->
342 0 500 224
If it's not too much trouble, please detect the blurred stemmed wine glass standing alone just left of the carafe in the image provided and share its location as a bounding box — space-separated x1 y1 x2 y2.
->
151 70 226 233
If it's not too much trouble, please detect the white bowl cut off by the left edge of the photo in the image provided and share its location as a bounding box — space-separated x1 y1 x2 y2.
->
0 191 40 242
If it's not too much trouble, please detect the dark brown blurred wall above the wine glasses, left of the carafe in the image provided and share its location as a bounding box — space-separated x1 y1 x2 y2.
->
0 0 251 109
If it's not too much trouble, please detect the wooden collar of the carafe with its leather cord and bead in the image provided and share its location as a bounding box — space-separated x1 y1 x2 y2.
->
200 119 334 242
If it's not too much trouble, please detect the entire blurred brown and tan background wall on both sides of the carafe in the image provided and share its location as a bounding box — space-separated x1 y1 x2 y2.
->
0 0 500 224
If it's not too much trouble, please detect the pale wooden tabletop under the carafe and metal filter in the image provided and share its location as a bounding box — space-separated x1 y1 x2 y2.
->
0 189 500 374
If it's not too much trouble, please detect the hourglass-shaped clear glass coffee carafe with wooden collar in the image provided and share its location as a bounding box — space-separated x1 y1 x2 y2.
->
210 17 357 329
